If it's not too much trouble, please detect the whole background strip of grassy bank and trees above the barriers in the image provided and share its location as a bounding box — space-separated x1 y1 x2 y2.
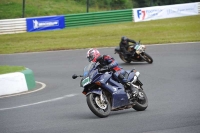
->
0 0 199 19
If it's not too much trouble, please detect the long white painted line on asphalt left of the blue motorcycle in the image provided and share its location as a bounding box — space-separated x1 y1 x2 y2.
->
0 94 78 111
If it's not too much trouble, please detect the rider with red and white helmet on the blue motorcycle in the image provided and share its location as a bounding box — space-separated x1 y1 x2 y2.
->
87 48 137 96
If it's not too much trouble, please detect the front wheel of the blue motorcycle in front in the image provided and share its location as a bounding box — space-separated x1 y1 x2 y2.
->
87 93 111 118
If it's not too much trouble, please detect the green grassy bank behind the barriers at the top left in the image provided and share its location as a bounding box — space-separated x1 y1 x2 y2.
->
0 0 106 19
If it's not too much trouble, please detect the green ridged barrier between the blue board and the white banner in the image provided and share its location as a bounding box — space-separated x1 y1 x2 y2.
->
65 9 132 28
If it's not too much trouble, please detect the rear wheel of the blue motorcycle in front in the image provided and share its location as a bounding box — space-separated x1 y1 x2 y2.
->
133 89 148 111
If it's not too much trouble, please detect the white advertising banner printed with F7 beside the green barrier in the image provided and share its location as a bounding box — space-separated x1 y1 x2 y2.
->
133 3 198 22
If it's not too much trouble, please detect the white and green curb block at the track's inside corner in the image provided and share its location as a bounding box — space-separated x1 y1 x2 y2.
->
0 68 36 96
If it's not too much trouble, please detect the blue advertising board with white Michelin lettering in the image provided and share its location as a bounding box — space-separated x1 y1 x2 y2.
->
26 16 65 32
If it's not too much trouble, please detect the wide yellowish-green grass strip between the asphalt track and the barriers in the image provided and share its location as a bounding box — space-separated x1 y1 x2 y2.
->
0 15 200 54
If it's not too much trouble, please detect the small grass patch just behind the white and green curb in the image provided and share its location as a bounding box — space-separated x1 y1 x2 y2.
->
0 66 26 74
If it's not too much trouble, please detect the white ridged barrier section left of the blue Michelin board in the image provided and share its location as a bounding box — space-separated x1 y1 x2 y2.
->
0 18 26 34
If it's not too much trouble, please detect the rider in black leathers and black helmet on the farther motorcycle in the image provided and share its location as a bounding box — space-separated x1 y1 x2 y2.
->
119 36 136 60
